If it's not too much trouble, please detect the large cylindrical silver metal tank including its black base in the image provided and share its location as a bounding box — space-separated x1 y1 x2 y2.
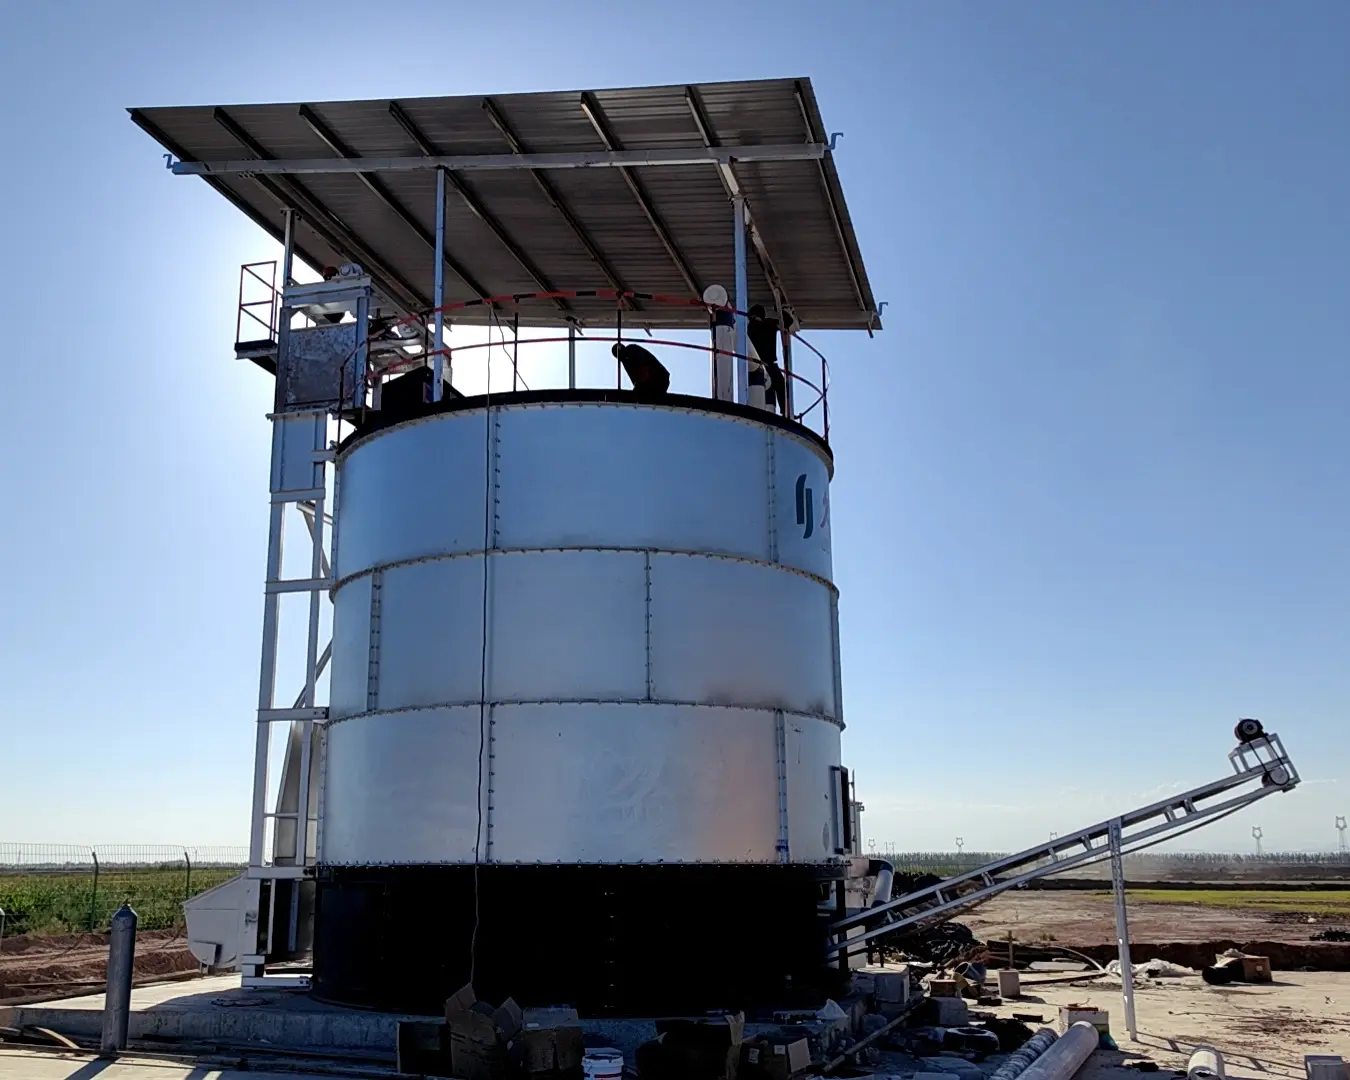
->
315 392 842 1010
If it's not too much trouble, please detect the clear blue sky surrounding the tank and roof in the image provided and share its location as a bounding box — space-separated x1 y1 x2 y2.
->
0 0 1350 851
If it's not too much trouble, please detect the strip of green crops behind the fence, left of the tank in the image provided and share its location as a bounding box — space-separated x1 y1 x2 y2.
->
0 864 239 937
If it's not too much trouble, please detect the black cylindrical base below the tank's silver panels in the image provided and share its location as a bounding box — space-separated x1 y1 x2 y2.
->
313 865 841 1017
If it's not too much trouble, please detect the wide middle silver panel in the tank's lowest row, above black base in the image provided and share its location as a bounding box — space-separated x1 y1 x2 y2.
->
491 705 778 863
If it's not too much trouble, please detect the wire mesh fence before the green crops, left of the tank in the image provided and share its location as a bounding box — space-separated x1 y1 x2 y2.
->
0 841 248 937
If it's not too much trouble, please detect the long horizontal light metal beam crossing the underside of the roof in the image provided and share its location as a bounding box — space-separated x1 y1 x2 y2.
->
169 143 829 177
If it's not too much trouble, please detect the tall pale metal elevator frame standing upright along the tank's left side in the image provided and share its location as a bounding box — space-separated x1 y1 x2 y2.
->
239 213 338 987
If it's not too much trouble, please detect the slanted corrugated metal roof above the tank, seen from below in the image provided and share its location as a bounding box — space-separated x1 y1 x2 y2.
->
130 78 880 329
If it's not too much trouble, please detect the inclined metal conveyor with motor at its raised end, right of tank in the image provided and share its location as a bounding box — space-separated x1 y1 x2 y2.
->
826 721 1299 960
